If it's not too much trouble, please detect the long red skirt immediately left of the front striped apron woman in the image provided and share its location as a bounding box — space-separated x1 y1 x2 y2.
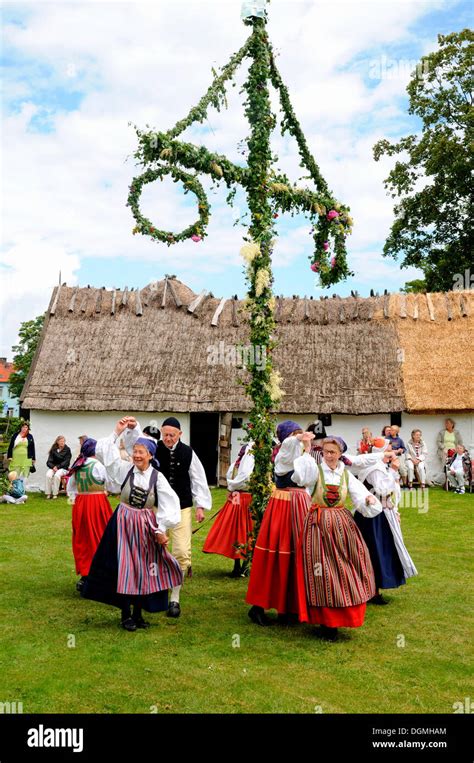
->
246 488 311 614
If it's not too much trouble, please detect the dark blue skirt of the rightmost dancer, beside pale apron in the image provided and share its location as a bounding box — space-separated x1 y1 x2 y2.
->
354 511 406 588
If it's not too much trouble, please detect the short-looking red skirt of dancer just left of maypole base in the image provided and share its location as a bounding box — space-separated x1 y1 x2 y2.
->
202 491 253 559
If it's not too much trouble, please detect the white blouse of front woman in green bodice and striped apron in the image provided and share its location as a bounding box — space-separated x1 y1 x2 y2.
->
292 453 382 517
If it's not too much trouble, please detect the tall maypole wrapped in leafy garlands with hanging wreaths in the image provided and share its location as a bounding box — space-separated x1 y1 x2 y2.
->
127 0 352 559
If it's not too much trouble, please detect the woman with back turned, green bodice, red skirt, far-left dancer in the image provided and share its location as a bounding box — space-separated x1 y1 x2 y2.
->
66 437 112 591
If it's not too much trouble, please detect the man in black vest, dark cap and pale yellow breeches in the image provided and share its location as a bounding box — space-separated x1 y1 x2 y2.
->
156 416 212 617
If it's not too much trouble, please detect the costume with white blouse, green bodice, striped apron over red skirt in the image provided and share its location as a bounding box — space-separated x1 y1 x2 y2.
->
293 454 382 628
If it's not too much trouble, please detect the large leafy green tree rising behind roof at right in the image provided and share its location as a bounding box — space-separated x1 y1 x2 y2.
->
374 29 474 291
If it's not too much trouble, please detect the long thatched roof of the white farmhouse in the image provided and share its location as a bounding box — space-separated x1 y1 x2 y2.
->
22 278 474 414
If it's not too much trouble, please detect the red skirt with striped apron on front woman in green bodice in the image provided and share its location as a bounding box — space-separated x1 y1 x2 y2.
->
296 506 376 628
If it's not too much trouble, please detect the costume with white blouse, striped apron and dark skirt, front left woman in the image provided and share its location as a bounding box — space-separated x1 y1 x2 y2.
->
81 432 182 612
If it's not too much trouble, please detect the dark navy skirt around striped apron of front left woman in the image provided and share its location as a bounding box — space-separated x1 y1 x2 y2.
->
81 508 168 612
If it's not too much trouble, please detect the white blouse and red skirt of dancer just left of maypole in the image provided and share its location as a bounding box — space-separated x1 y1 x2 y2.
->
202 443 254 559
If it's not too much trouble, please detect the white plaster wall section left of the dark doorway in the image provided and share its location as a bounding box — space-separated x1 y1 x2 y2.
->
27 411 190 491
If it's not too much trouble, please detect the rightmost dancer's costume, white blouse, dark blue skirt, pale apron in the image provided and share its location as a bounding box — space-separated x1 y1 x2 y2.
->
354 454 418 588
